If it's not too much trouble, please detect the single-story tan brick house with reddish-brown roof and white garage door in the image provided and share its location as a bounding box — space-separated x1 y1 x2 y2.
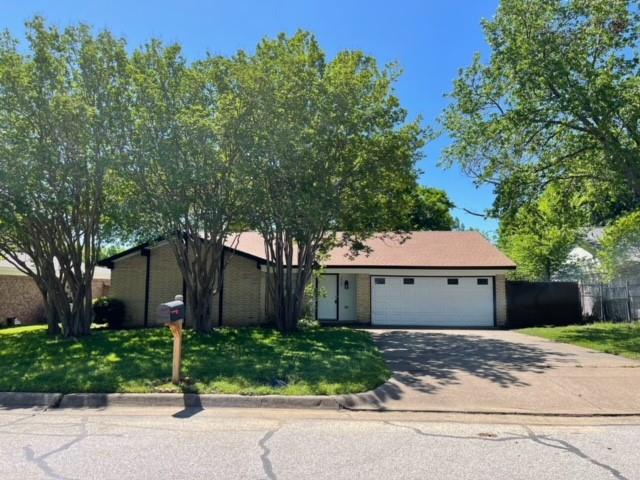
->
101 232 515 327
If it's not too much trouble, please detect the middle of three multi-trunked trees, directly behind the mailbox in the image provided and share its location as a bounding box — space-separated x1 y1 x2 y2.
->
123 41 245 332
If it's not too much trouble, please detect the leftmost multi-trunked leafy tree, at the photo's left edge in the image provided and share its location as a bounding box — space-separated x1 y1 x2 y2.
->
0 17 128 336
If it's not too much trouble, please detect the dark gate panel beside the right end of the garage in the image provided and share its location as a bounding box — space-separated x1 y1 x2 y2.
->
507 282 582 328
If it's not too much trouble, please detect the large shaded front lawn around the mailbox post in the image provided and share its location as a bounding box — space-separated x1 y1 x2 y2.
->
0 326 390 395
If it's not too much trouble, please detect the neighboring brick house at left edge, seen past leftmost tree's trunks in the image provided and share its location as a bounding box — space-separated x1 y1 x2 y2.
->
0 257 111 325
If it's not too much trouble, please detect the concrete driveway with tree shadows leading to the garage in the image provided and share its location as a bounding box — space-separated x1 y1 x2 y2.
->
346 330 640 415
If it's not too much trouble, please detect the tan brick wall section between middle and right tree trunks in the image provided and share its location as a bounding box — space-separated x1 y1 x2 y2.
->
222 251 266 326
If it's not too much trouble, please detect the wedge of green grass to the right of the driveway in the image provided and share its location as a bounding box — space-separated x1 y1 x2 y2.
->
518 323 640 359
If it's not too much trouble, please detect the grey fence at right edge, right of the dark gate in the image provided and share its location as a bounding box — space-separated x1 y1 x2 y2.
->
580 275 640 322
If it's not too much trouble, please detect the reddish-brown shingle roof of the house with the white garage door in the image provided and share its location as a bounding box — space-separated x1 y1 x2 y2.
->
101 231 516 269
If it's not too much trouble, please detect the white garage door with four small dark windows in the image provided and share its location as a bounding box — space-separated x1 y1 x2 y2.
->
371 276 493 327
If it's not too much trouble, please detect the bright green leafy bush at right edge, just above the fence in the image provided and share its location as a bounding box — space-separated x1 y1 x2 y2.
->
598 210 640 278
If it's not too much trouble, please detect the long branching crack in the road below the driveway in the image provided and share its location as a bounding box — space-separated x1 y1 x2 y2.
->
382 421 629 480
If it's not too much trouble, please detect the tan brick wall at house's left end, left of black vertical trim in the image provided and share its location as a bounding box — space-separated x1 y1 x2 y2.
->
109 253 147 327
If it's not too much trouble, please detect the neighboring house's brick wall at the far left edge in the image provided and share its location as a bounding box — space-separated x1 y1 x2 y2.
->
0 275 44 325
